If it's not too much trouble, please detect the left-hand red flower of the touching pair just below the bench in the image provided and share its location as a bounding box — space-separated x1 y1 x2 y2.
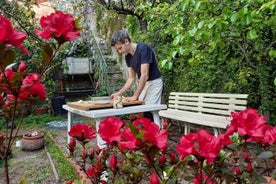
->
176 133 197 159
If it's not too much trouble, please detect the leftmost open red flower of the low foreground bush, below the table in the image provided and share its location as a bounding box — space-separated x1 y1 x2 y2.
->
68 123 96 142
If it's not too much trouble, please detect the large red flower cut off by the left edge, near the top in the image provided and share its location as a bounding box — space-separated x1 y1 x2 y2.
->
0 16 28 54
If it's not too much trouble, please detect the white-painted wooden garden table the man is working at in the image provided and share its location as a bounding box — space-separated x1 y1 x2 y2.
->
62 104 167 148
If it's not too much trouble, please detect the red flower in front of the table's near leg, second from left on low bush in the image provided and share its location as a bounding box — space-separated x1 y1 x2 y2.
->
98 117 124 144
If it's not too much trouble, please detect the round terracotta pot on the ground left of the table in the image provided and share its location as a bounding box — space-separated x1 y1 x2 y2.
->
22 132 44 151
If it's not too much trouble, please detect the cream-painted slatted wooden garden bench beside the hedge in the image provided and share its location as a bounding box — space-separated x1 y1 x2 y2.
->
159 92 248 136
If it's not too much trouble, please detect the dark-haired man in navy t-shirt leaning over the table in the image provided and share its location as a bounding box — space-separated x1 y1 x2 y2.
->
111 30 163 121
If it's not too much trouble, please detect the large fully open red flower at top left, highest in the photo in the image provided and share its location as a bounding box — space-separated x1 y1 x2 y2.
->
35 11 80 44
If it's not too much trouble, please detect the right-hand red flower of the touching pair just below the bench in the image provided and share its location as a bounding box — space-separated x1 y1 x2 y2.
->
197 130 221 163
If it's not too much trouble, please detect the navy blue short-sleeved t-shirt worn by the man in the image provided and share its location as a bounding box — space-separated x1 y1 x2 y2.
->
125 42 161 81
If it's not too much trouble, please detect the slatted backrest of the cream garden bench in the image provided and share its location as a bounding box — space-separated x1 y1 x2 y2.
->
168 92 248 116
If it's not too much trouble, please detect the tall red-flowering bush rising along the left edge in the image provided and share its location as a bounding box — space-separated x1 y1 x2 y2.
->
0 11 80 183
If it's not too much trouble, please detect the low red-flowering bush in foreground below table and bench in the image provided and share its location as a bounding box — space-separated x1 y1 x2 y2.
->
69 108 276 184
